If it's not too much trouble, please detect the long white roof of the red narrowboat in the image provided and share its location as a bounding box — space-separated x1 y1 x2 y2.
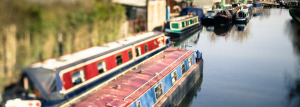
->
31 32 163 71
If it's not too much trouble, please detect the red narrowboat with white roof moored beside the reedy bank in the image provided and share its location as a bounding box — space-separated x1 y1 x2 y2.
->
4 32 170 106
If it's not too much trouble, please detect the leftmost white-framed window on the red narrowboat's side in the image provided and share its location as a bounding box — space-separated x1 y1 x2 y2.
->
72 69 85 86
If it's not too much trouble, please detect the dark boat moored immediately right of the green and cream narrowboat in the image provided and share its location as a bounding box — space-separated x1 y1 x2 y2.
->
202 10 220 25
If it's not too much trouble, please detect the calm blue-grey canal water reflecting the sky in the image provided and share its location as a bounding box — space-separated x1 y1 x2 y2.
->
174 8 300 107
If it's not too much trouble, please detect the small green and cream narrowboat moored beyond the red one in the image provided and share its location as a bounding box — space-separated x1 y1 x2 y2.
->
164 8 204 36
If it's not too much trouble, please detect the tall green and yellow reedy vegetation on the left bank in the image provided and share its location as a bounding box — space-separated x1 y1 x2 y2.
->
0 0 126 92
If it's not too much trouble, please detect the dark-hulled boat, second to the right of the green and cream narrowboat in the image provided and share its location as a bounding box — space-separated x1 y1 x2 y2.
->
215 9 233 25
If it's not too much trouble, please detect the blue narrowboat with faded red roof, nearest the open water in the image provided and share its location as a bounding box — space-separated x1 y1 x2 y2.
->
71 48 202 107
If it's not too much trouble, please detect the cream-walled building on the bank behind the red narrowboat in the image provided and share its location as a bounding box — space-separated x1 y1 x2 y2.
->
112 0 166 33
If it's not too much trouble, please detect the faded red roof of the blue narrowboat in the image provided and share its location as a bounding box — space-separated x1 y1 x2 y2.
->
74 48 193 107
